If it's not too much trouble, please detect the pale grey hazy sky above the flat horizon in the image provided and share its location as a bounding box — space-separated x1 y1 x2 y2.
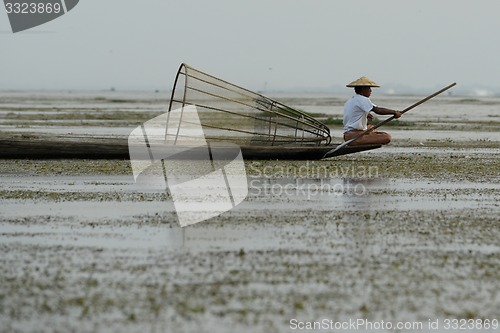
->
0 0 500 93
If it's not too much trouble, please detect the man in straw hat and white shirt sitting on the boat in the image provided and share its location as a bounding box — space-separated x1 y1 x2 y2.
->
344 76 401 146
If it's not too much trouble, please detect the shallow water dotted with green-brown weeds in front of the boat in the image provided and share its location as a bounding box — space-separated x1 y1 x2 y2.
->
0 147 500 332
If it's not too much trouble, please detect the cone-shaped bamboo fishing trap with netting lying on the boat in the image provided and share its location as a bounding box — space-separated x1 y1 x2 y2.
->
168 64 331 146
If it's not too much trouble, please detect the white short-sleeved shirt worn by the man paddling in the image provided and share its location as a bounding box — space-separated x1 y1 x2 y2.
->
344 94 376 133
